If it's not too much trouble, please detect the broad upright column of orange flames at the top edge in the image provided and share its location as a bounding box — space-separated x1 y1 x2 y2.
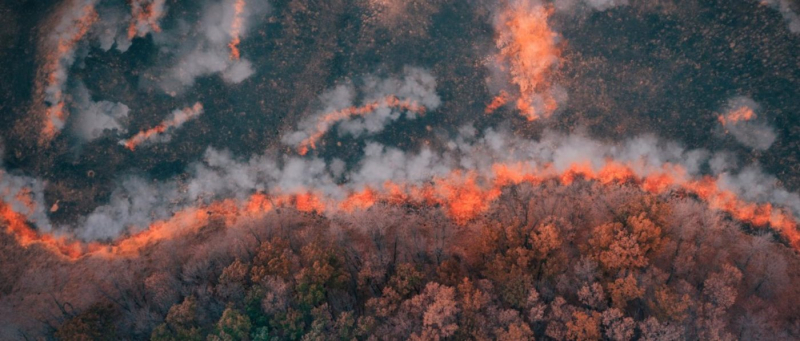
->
485 1 561 121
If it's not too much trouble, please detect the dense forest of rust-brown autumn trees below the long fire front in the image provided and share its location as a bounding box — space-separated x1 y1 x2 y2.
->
7 181 800 340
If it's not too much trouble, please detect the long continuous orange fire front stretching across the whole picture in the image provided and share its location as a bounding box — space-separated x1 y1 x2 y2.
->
6 160 800 259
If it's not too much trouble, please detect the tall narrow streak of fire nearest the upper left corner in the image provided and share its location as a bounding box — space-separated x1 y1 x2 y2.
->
40 4 98 143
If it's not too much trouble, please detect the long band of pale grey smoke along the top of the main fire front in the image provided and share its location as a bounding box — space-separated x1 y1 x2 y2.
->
4 126 800 240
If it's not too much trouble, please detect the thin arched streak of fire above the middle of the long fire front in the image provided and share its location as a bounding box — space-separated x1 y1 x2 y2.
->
297 95 425 155
